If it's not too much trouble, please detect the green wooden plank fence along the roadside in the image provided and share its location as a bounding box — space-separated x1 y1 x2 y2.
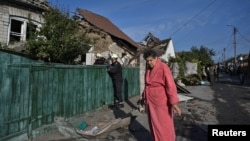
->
0 50 140 140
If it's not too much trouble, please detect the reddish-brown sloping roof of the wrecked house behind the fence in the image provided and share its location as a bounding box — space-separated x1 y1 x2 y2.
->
77 8 139 48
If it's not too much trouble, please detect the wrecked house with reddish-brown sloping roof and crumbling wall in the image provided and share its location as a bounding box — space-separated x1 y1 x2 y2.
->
77 9 140 66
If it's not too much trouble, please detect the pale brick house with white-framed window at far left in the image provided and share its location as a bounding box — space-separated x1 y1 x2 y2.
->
0 0 49 51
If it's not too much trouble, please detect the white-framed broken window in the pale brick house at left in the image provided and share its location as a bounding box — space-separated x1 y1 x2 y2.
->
9 17 39 43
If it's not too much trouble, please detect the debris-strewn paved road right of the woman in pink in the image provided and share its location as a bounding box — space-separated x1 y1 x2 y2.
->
176 74 250 141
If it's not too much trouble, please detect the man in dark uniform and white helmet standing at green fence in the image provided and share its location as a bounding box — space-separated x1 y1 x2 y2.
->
108 54 124 108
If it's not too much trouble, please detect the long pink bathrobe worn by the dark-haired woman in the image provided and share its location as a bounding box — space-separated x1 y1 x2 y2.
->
143 59 179 141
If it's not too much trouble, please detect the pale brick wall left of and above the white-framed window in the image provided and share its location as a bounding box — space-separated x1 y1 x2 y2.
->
0 2 42 44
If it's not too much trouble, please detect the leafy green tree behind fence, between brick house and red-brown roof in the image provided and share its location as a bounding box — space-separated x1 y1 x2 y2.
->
25 8 90 64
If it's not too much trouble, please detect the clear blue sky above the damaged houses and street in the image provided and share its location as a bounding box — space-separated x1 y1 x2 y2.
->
48 0 250 62
